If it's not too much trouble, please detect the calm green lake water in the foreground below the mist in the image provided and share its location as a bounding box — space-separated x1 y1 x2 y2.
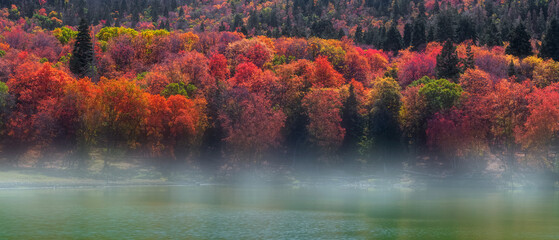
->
0 186 559 240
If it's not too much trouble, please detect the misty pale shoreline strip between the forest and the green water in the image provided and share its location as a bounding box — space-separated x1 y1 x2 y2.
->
0 171 559 191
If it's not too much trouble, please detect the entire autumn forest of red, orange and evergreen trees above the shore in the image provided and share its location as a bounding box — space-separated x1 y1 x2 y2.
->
0 0 559 178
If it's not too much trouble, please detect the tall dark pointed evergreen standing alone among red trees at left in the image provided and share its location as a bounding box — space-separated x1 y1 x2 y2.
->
70 18 95 78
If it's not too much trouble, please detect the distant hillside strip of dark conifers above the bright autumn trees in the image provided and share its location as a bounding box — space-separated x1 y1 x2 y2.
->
0 0 559 51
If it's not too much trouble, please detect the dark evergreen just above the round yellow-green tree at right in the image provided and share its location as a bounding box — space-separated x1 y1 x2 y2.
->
435 40 460 80
